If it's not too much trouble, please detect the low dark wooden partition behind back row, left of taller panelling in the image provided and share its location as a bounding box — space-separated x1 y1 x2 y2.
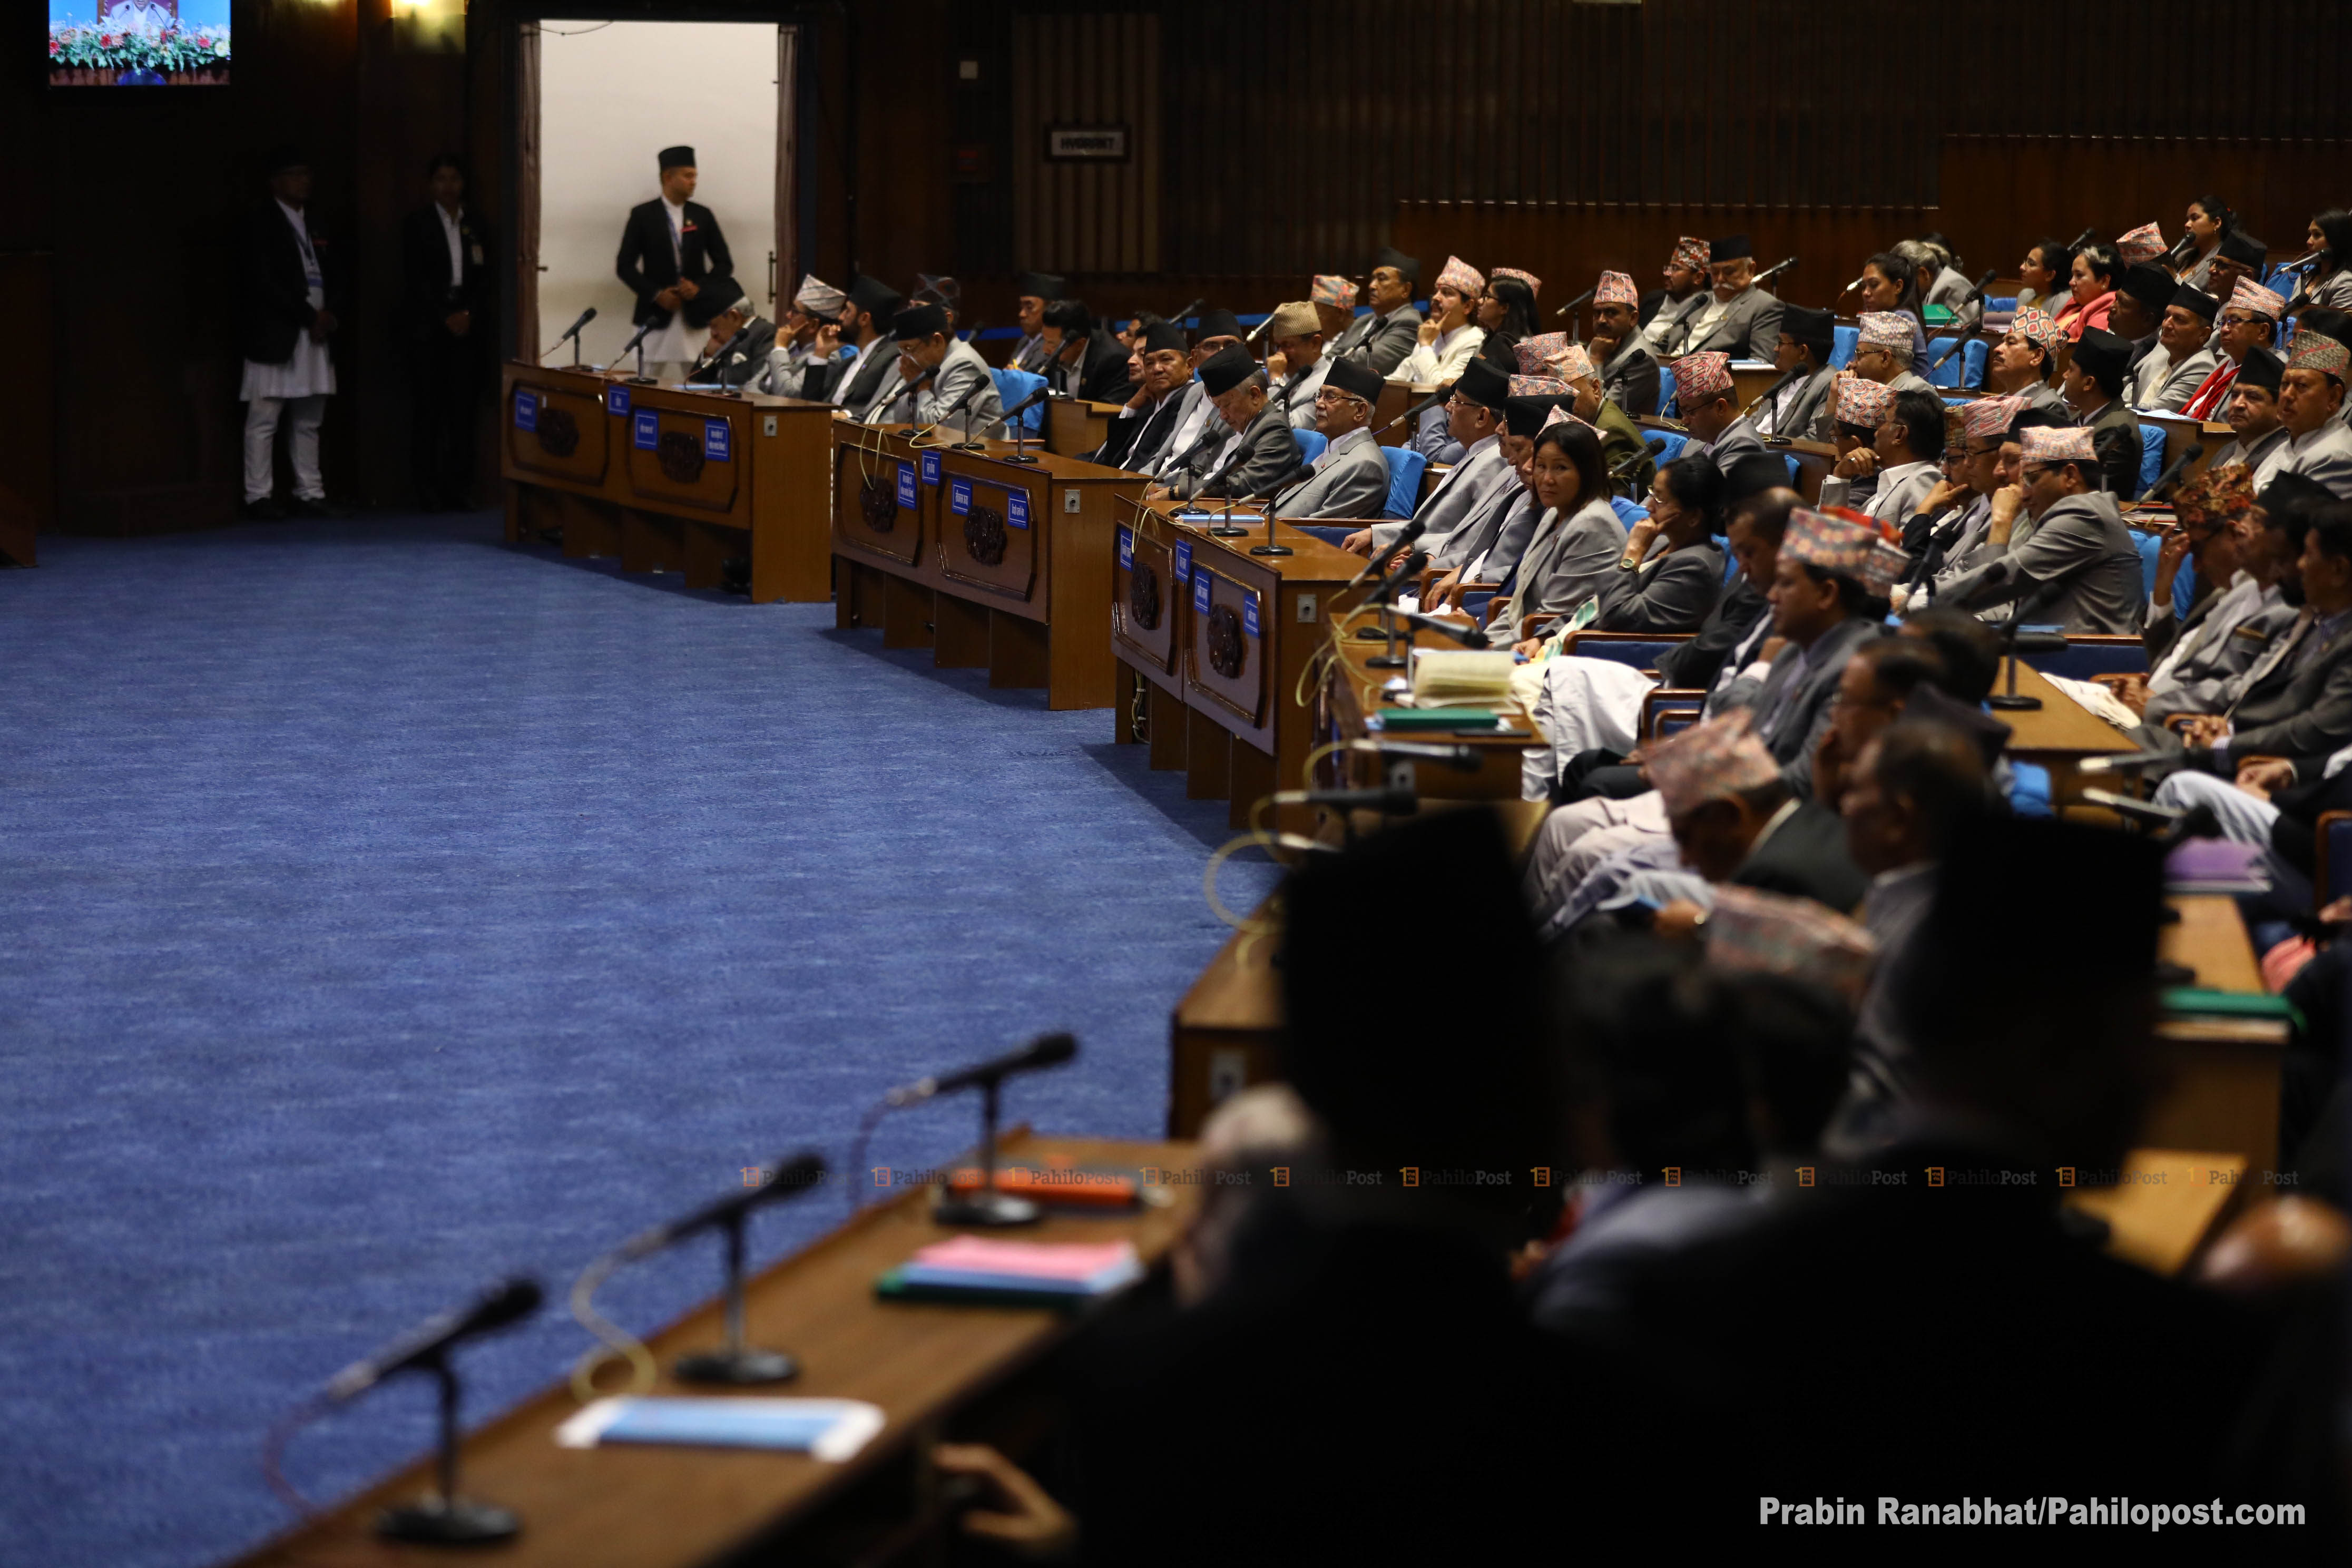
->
1395 202 1938 319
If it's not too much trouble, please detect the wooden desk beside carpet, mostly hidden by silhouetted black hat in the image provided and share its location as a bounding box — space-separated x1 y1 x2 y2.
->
1169 799 1550 1138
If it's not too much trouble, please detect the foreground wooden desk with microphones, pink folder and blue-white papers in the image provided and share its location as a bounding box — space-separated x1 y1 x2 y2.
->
238 1135 1197 1568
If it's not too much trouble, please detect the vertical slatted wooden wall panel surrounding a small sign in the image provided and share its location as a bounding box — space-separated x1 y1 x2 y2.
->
1007 14 1160 273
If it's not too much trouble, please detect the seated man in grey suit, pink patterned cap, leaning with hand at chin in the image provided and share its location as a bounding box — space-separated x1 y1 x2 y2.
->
1936 425 2148 635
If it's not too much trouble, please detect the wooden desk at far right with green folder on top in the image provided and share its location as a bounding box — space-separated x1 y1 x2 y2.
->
2140 893 2286 1171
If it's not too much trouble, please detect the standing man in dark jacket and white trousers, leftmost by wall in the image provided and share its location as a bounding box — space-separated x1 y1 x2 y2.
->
238 146 344 520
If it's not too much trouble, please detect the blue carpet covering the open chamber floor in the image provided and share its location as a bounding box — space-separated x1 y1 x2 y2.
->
0 517 1270 1568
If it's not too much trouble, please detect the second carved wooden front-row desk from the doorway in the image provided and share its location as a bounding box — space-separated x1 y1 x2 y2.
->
832 421 1145 708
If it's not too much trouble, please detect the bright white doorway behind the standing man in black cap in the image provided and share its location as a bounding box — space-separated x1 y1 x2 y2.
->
520 19 800 365
